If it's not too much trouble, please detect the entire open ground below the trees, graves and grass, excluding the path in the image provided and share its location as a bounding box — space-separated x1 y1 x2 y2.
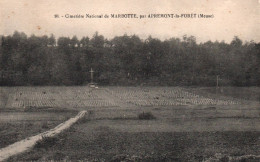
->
0 86 260 161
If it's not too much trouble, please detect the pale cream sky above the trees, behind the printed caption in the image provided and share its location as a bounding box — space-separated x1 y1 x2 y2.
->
0 0 260 42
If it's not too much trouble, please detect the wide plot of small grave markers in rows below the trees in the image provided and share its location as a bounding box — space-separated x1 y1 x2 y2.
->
2 87 240 108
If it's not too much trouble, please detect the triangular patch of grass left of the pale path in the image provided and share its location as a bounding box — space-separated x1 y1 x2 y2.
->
0 111 77 148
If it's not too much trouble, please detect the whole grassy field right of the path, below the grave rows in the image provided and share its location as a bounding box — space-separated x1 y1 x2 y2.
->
8 104 260 161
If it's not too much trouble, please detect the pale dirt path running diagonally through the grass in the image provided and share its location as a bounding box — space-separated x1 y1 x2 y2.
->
0 111 87 161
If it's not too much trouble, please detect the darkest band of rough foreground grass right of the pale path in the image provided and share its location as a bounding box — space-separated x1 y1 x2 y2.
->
8 121 260 161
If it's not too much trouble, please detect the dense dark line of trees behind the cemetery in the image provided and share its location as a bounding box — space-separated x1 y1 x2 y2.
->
0 31 260 86
